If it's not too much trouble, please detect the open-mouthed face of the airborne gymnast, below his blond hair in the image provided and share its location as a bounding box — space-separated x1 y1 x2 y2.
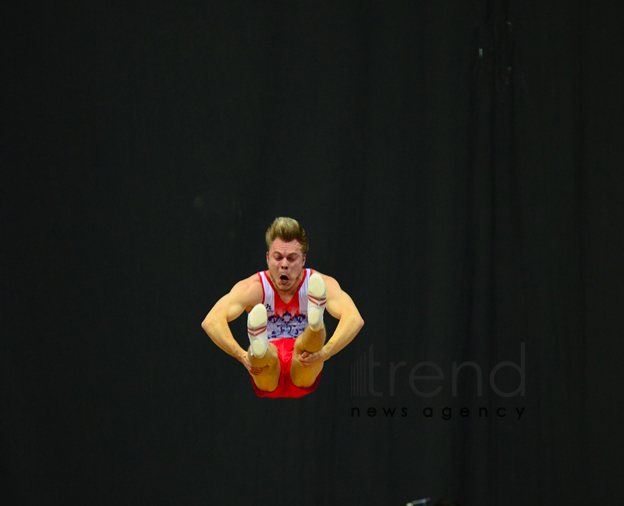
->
267 239 306 292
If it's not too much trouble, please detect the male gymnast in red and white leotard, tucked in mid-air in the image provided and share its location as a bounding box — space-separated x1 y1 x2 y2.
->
202 217 364 398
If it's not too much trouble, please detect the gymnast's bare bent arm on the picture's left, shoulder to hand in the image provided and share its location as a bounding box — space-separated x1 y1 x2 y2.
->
202 274 262 369
